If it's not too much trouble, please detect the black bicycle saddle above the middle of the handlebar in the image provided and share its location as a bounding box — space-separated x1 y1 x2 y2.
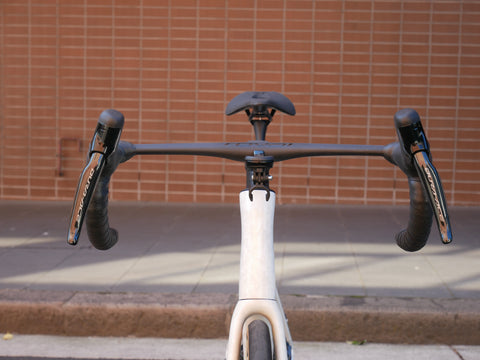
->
225 91 295 115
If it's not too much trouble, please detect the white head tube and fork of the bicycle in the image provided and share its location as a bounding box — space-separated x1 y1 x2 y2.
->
226 190 293 360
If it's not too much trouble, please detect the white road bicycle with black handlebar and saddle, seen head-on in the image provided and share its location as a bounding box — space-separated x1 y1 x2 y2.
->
68 91 452 360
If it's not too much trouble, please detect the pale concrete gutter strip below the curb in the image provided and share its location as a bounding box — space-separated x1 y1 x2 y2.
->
0 335 480 360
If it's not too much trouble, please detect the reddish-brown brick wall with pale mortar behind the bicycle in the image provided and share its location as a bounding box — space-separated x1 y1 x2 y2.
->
0 0 480 205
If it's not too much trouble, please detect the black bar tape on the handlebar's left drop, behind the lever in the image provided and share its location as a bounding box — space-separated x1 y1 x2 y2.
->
85 141 134 250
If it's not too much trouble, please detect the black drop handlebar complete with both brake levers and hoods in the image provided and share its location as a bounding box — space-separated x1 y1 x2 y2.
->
68 98 452 251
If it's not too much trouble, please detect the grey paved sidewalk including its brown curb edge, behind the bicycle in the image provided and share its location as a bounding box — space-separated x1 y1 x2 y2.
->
0 201 480 345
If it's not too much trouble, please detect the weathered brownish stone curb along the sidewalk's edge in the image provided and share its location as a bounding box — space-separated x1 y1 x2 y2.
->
0 289 480 345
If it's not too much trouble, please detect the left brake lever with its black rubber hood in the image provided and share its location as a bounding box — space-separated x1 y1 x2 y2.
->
67 109 124 245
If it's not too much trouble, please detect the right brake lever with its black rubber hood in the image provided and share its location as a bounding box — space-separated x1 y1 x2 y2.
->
395 109 452 244
